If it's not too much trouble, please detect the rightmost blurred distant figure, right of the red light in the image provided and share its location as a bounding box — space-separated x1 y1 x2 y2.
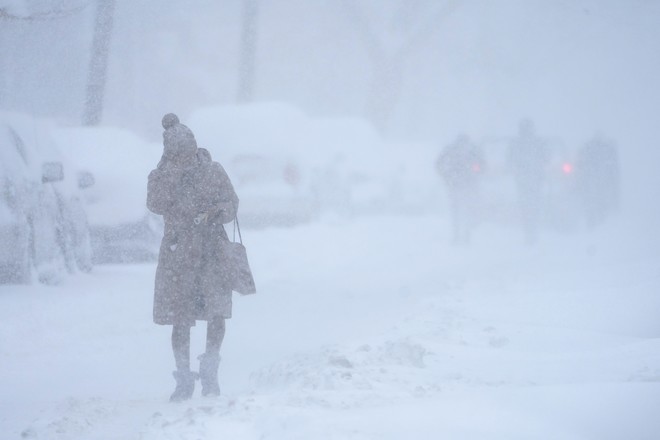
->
576 135 620 229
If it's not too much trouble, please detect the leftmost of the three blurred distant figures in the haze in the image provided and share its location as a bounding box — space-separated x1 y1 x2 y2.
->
436 134 484 244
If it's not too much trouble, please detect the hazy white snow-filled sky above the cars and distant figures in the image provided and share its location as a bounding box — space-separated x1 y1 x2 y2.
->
0 0 660 223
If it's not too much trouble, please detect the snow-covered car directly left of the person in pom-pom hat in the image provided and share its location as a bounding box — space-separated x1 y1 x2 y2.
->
54 127 163 264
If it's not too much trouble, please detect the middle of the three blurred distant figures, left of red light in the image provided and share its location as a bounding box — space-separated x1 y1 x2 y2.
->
508 119 550 245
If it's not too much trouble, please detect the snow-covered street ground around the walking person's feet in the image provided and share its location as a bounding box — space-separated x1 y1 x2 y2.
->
0 212 660 440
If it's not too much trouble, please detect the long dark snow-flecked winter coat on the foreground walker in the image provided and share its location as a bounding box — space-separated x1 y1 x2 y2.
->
147 148 238 325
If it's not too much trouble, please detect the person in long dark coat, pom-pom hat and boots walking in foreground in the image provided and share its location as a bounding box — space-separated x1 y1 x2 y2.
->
147 113 238 401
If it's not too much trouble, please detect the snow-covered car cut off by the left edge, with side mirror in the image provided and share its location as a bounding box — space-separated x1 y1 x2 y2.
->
0 112 92 284
